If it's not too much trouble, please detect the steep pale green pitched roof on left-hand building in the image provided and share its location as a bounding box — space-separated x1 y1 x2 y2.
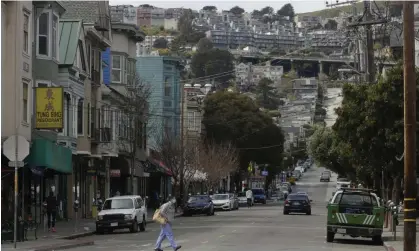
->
59 19 83 65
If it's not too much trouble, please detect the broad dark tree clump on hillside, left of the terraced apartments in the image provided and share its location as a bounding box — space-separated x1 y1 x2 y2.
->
191 49 234 83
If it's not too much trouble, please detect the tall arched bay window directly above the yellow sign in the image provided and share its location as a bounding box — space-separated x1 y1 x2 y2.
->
36 10 59 60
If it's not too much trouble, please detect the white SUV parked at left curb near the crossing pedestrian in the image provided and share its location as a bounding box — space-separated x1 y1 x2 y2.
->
96 195 147 234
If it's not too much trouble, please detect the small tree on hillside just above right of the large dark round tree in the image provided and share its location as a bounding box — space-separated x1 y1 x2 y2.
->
256 78 280 110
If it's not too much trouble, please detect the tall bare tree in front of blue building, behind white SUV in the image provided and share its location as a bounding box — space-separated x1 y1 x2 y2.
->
116 76 151 194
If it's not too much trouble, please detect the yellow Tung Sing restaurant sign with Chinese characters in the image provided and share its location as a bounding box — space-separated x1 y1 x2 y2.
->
35 87 64 129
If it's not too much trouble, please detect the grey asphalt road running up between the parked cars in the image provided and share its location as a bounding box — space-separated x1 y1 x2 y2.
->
73 167 383 251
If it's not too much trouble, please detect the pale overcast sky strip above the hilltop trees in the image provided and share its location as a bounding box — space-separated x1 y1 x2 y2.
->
109 0 331 13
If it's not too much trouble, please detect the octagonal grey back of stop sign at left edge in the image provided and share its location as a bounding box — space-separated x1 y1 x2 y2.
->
3 135 29 161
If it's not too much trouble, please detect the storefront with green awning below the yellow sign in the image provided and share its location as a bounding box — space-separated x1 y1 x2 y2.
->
26 139 73 222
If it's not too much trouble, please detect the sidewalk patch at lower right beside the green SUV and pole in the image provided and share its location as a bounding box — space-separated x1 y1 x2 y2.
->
383 214 419 251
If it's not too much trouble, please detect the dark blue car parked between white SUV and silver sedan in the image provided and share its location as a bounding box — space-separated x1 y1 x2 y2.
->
183 195 214 216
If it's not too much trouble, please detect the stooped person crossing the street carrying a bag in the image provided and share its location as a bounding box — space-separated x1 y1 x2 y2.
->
154 198 182 251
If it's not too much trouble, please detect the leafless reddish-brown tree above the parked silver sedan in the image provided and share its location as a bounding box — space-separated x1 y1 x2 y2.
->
199 143 238 189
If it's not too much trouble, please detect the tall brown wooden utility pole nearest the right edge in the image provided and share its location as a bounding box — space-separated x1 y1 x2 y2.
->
403 1 416 251
